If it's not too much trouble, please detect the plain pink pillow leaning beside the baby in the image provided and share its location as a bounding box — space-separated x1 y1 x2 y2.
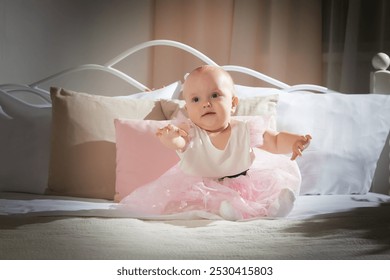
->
114 119 179 201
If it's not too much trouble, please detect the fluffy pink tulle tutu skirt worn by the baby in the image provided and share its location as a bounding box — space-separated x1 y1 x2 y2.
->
120 151 301 219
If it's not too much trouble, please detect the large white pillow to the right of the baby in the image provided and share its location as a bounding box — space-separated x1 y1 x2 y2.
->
277 92 390 194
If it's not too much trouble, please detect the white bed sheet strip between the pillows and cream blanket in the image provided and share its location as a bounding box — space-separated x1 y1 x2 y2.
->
0 192 390 220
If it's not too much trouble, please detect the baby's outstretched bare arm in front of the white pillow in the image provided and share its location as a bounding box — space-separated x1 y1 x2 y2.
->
259 131 311 160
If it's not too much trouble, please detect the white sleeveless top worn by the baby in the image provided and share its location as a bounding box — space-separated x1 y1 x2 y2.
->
178 120 255 178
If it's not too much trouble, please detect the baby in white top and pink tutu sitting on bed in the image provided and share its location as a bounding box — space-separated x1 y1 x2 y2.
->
122 66 311 220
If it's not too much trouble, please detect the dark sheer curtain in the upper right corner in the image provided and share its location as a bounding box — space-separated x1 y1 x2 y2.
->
322 0 390 93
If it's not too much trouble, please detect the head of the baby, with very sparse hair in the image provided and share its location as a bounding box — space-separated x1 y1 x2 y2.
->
183 67 238 132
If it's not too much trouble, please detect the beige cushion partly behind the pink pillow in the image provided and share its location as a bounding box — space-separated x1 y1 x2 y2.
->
46 87 165 199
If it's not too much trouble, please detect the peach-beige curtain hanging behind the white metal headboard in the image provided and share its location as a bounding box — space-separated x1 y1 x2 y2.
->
152 0 322 87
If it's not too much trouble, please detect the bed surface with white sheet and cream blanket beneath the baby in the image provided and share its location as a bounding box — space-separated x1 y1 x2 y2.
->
0 193 390 260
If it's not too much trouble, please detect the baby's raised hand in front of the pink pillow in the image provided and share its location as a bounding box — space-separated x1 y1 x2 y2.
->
156 124 188 151
